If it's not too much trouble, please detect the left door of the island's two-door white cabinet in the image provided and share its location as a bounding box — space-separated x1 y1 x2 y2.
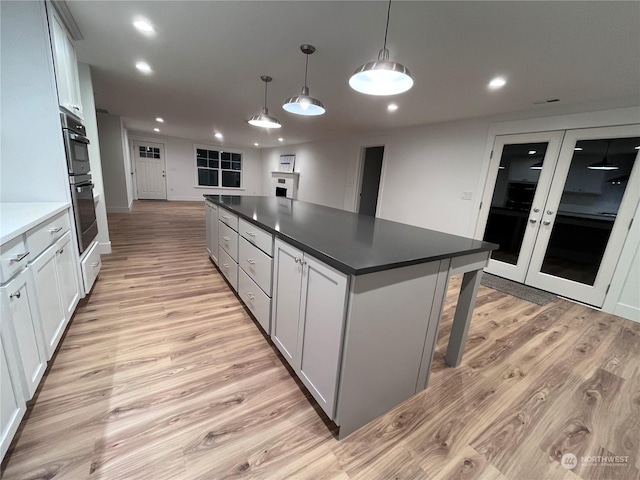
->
271 240 303 368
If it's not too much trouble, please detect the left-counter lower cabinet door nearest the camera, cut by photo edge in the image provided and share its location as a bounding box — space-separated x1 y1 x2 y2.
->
0 328 27 460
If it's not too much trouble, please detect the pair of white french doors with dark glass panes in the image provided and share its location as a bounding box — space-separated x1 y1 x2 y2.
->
479 125 640 307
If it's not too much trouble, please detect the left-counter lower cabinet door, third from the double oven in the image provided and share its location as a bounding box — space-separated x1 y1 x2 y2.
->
1 268 47 400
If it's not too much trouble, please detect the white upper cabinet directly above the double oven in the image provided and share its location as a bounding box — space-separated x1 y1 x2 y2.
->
49 9 82 118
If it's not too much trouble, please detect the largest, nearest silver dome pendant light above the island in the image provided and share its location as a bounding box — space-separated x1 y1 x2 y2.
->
349 0 413 95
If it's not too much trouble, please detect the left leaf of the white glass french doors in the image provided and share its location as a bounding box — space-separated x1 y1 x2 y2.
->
479 132 564 282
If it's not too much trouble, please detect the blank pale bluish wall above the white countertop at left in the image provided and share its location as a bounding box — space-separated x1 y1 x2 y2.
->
0 2 71 202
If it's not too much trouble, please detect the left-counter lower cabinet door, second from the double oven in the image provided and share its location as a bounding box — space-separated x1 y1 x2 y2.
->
30 245 66 360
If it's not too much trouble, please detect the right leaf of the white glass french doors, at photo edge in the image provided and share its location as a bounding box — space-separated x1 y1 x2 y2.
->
525 125 640 307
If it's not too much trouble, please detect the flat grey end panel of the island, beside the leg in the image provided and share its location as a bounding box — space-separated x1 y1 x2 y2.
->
335 260 449 439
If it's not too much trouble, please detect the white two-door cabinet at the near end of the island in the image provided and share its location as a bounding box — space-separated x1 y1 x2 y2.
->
271 240 349 418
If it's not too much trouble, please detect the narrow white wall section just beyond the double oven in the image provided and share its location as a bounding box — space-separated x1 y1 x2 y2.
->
97 112 132 213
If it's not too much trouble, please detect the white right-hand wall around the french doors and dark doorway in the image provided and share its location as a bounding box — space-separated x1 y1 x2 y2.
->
262 108 640 319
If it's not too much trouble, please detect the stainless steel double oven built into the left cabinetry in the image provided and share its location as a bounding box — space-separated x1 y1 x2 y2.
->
60 113 98 254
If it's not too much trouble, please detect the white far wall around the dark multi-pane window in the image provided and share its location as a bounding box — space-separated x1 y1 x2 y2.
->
128 131 268 201
